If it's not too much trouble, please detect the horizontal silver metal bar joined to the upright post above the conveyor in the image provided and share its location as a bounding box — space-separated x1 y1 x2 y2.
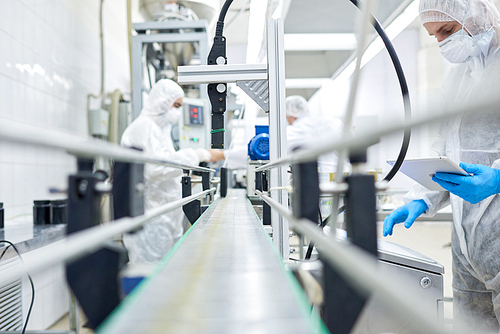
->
177 64 267 85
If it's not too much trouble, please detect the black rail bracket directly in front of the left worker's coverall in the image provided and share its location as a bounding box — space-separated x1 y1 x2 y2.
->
113 161 144 219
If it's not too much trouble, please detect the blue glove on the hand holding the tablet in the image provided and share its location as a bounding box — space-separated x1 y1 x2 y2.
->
432 162 500 204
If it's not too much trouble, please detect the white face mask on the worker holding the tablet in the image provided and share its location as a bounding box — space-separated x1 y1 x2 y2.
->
438 28 493 63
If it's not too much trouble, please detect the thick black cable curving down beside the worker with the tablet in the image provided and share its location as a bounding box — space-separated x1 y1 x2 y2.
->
305 0 411 260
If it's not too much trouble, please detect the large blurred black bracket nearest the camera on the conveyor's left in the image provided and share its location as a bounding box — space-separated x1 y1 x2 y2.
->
66 171 127 329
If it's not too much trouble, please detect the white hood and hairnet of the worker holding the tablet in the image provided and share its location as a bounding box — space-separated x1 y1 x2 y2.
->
419 0 500 69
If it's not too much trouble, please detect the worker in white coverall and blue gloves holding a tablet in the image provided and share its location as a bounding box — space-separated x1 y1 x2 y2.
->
383 0 500 333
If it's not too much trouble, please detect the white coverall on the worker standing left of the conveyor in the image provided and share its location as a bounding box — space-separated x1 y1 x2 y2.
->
121 79 210 263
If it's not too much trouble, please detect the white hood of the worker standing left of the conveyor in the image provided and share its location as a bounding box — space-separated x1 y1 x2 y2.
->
144 79 184 115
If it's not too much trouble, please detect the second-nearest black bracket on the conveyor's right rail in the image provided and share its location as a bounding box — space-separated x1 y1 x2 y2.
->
292 161 319 222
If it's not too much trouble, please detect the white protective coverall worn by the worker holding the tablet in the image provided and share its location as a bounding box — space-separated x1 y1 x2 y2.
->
405 0 500 333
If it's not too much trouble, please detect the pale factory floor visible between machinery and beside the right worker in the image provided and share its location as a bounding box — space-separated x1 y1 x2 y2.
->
49 222 453 334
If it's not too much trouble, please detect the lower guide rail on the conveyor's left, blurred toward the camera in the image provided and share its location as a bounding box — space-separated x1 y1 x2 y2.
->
0 188 216 284
